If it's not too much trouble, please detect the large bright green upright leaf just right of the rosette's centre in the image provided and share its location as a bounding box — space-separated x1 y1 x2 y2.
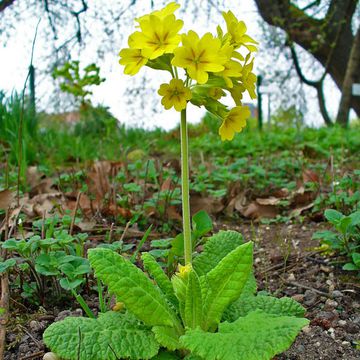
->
200 242 253 329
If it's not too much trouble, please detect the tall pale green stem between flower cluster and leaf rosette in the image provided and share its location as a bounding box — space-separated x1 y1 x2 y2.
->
180 108 192 265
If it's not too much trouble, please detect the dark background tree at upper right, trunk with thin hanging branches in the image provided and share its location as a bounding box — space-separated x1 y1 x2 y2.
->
255 0 360 125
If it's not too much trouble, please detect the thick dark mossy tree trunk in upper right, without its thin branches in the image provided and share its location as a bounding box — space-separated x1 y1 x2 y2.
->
255 0 360 117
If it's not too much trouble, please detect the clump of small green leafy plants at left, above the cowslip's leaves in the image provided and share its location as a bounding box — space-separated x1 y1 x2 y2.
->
0 216 91 304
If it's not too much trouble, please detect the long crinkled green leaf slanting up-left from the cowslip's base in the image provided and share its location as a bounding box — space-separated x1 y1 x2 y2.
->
88 249 177 326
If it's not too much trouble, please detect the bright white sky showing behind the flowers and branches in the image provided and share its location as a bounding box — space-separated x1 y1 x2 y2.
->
0 0 350 129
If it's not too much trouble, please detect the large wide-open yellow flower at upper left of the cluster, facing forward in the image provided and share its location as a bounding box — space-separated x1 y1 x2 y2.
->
129 15 184 59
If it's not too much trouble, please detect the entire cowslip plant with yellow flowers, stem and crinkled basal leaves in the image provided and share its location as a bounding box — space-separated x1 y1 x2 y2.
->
44 3 308 360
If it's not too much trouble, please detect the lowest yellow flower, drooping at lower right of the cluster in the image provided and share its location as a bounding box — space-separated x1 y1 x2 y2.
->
219 106 250 141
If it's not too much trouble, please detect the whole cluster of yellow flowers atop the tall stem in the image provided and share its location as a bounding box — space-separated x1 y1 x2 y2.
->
119 2 257 140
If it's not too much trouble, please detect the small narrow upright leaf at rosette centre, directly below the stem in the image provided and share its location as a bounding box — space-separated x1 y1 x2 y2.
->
184 269 203 329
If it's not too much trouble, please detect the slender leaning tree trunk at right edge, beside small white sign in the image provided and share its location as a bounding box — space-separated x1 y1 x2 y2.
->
336 28 360 126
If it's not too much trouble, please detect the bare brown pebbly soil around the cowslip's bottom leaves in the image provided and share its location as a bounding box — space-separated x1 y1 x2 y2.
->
5 223 360 360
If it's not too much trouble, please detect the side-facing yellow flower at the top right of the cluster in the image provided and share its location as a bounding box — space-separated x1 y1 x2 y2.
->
222 10 258 52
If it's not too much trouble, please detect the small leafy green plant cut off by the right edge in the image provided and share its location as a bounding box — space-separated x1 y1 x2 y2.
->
313 209 360 271
